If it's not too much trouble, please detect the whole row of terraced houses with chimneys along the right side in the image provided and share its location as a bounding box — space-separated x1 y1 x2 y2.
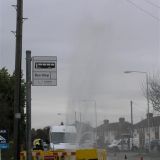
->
97 113 160 147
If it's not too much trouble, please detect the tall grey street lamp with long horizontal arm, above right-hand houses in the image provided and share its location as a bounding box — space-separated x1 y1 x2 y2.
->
124 71 150 151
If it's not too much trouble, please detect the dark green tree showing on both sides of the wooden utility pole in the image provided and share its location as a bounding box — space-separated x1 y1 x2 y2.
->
0 68 25 156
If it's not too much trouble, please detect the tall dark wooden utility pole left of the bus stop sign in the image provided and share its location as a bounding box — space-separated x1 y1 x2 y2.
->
14 0 23 160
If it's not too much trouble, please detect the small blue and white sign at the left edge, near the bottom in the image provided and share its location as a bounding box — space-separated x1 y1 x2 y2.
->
0 129 8 149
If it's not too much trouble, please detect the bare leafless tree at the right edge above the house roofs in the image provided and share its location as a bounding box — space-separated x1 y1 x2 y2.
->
148 76 160 112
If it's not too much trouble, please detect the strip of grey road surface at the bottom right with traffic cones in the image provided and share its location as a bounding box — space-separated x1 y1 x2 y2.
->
107 152 160 160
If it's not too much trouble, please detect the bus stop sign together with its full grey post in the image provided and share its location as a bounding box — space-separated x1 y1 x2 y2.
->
26 54 57 160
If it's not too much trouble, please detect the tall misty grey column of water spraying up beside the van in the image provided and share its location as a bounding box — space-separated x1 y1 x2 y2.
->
64 19 109 148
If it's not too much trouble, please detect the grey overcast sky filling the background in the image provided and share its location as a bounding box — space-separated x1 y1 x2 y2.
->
0 0 160 128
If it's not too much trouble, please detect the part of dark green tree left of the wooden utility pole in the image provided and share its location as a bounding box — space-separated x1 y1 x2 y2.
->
0 68 14 134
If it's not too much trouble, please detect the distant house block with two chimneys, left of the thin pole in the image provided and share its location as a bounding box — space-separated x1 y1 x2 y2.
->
97 118 131 143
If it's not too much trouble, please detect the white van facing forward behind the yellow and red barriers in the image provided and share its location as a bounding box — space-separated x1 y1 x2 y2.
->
49 125 77 150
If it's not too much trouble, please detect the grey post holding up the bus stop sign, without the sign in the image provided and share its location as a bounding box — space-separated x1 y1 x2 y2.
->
26 51 32 160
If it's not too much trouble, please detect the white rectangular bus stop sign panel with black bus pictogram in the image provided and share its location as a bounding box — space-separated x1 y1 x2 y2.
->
32 56 57 86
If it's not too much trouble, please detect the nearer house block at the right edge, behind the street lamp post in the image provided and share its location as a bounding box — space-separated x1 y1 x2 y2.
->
133 113 160 147
